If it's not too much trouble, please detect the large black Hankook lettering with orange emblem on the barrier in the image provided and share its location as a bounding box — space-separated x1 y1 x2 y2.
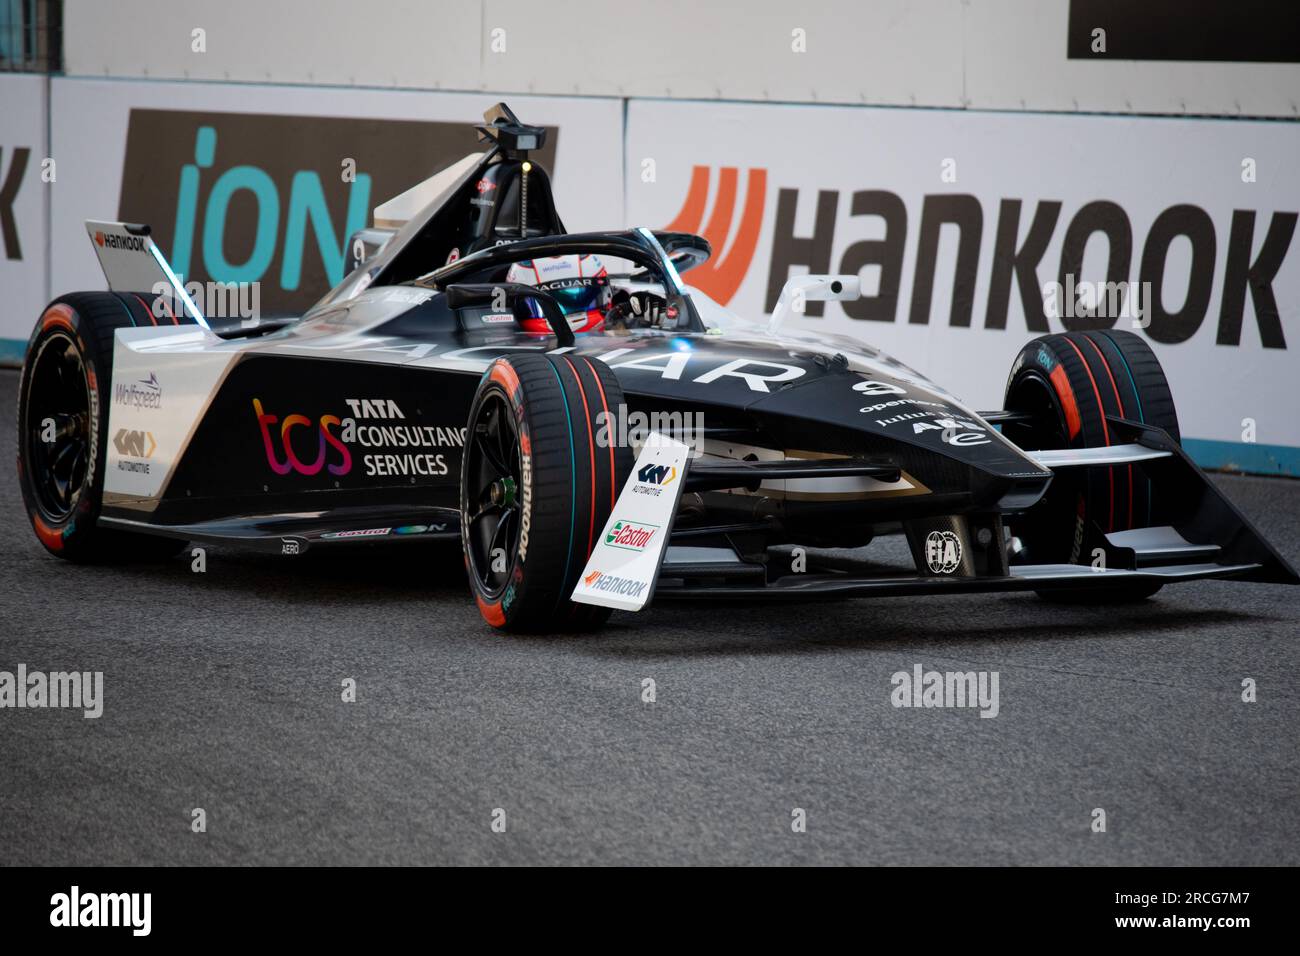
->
667 165 1300 349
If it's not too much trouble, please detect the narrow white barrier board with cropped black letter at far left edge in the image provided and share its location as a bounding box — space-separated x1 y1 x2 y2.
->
0 75 48 363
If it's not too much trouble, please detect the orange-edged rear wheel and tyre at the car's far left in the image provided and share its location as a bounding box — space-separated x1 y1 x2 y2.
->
18 293 186 562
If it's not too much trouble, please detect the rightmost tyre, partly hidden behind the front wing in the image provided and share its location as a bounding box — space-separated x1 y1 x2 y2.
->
1005 329 1180 604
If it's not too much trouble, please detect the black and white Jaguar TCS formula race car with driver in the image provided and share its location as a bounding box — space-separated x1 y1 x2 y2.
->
18 104 1297 630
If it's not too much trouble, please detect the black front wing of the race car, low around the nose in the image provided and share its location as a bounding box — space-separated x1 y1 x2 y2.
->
573 418 1300 610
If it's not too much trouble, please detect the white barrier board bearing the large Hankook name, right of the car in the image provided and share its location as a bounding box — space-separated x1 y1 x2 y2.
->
627 101 1300 471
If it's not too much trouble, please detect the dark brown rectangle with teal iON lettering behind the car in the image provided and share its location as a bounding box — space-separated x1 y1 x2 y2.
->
118 109 501 311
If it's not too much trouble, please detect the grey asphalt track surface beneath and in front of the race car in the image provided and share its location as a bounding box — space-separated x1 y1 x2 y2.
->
0 361 1300 865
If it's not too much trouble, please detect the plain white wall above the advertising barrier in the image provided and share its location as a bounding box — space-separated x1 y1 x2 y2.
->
65 0 1300 117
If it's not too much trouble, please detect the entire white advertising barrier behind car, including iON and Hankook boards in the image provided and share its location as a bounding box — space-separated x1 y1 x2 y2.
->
0 75 1300 475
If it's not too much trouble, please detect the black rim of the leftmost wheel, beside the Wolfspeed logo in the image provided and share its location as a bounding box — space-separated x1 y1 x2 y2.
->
23 332 91 523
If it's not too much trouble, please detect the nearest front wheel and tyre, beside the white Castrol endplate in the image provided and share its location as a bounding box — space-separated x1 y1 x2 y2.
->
460 354 632 631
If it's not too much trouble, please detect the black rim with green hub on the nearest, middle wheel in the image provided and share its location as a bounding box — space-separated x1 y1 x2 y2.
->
460 390 523 598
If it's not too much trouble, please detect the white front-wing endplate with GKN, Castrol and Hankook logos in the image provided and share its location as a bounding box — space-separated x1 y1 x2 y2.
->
573 432 690 611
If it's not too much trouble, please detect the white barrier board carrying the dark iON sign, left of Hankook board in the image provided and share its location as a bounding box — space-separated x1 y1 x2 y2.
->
51 79 623 313
